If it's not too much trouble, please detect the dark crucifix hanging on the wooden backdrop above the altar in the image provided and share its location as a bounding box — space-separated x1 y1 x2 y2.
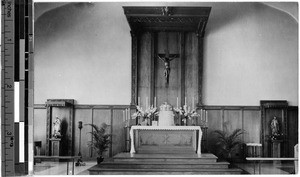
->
157 34 179 85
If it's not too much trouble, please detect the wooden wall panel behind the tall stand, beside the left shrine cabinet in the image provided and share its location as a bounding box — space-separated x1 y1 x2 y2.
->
74 109 92 159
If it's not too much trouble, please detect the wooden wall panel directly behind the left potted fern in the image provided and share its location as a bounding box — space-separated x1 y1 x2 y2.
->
92 109 112 158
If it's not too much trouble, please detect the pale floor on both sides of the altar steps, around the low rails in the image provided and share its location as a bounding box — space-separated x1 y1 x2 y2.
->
34 161 294 175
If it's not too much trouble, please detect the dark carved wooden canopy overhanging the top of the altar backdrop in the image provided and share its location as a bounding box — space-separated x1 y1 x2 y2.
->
123 7 211 35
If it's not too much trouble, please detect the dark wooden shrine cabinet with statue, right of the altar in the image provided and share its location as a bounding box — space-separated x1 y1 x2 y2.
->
260 100 288 157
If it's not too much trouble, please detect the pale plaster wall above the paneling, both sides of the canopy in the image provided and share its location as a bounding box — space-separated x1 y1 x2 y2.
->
34 2 298 106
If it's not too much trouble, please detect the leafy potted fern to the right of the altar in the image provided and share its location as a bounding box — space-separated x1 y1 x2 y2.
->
213 129 244 161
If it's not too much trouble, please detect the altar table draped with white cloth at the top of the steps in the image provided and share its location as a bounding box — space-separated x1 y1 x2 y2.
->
130 126 202 154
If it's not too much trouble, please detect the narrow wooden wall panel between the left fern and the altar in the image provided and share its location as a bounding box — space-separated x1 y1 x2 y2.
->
112 109 126 156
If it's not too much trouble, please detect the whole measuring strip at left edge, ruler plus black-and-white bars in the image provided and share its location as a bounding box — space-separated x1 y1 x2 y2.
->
1 0 33 176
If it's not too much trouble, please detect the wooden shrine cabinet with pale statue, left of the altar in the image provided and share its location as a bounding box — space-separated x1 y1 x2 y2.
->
46 99 74 156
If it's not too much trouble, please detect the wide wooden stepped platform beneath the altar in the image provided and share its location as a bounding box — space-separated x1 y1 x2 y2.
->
89 153 242 175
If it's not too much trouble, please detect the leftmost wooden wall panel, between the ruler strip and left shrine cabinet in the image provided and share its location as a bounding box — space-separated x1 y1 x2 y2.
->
33 108 47 155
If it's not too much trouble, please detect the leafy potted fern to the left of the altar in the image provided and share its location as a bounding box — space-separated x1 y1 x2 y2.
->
87 123 111 164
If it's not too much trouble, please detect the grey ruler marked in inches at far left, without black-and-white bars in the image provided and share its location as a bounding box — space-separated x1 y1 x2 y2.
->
1 0 15 176
